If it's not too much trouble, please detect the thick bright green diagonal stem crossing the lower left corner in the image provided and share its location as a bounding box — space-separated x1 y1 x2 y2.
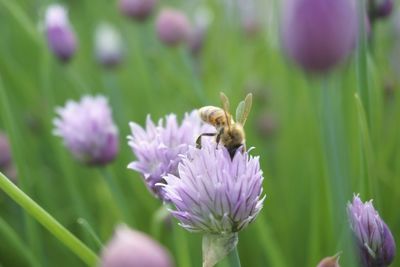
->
0 173 98 266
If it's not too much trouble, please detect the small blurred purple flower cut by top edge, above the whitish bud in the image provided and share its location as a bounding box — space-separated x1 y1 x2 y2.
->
118 0 157 21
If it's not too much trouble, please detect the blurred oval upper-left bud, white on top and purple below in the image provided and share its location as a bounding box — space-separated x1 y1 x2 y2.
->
45 4 77 62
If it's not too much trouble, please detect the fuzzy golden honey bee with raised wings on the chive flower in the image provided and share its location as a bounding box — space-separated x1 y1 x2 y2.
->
196 92 253 158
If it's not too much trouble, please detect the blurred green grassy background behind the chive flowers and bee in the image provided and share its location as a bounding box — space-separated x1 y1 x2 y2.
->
0 0 400 267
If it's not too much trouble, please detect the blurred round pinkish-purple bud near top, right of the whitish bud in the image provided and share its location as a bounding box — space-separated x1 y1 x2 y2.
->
156 8 191 46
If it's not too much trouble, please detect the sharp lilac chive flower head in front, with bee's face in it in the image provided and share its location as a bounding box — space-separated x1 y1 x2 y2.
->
163 142 264 235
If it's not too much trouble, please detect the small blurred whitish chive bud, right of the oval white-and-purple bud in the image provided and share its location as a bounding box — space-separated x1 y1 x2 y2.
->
94 23 122 68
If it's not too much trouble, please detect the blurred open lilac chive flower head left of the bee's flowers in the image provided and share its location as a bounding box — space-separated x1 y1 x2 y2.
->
54 95 118 165
